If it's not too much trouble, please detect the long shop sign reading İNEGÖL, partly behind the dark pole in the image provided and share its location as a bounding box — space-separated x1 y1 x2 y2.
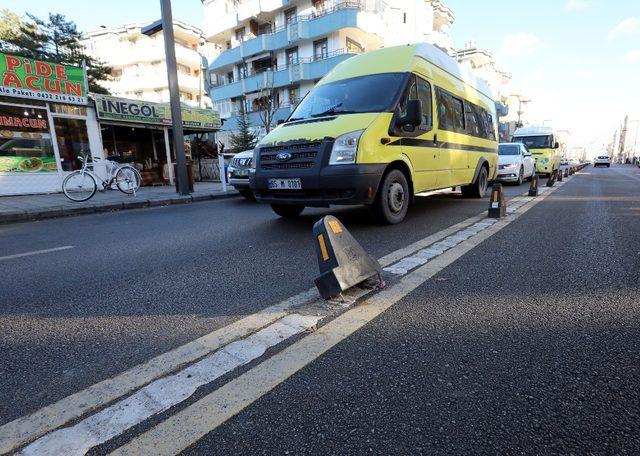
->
92 94 221 130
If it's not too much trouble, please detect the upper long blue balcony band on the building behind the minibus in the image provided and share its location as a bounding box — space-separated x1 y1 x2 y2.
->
209 1 375 71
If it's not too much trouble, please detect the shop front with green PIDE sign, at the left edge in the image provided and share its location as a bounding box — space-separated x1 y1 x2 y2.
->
0 53 102 195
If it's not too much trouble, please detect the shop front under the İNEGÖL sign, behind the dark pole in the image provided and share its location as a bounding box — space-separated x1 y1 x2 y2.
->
92 94 221 185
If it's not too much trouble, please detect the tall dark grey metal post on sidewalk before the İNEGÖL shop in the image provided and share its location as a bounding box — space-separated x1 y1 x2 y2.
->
160 0 189 195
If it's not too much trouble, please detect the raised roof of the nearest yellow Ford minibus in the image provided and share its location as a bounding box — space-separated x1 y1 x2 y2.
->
320 43 494 100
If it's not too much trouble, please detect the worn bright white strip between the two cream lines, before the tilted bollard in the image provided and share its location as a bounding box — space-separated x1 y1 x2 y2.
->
20 314 321 456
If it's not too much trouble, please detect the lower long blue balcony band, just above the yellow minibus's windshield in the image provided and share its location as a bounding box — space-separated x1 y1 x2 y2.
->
209 49 355 101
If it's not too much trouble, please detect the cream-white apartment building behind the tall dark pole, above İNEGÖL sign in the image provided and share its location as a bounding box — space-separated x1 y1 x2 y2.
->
83 20 219 107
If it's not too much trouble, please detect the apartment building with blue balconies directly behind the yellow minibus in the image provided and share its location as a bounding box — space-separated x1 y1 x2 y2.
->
202 0 454 144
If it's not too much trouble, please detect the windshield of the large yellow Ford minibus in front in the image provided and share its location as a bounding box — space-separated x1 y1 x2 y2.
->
289 73 406 121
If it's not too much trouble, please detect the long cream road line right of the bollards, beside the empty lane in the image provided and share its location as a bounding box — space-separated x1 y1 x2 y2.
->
111 181 564 456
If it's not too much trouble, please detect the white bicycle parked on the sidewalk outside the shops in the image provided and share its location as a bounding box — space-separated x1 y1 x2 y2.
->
62 154 142 202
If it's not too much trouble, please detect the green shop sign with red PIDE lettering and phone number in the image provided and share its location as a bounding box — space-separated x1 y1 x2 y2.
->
0 52 87 104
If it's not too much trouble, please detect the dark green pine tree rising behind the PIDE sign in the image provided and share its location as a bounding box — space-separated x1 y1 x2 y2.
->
5 13 109 94
